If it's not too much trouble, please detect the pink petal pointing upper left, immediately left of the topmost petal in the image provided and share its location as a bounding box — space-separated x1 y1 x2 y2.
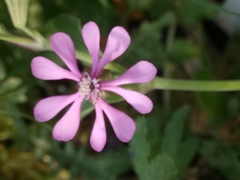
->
50 32 81 77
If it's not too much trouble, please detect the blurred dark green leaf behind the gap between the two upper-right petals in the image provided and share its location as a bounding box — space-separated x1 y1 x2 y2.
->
120 13 175 67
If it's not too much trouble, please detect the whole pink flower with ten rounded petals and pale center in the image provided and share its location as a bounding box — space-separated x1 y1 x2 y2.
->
31 22 157 152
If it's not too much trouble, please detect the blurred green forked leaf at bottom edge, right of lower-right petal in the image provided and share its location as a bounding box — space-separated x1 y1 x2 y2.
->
130 117 177 180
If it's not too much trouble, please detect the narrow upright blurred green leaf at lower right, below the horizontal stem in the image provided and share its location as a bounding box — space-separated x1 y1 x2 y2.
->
162 106 189 158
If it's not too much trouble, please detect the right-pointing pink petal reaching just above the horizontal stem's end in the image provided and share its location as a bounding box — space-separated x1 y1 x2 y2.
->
101 61 157 86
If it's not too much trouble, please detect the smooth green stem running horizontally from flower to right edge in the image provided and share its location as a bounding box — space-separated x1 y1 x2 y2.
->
151 77 240 92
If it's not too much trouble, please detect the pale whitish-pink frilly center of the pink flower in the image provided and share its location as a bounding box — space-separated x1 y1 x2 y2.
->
77 72 101 104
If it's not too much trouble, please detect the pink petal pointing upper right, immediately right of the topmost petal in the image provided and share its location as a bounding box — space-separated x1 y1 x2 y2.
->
96 26 131 76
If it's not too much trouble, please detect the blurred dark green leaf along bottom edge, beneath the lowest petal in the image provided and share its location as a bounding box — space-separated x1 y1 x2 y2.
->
52 142 131 180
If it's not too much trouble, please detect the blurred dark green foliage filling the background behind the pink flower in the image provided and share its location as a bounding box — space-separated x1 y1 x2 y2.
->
0 0 240 180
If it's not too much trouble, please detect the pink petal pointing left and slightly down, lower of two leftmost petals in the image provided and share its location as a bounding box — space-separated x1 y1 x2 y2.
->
34 92 80 122
